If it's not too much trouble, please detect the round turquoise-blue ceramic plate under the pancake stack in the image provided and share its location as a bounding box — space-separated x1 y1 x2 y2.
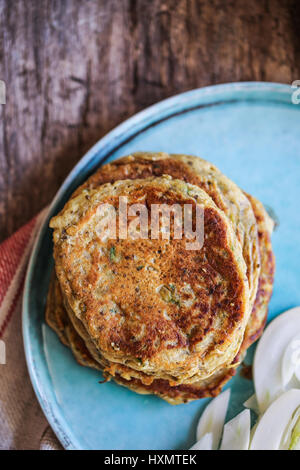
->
23 83 300 450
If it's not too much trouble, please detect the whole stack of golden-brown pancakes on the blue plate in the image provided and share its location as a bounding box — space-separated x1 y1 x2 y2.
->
46 152 275 404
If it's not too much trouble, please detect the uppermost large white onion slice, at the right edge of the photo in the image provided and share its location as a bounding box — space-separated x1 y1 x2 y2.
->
253 307 300 413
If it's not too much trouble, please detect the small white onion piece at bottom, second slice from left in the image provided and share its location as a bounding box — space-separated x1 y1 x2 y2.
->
220 410 251 450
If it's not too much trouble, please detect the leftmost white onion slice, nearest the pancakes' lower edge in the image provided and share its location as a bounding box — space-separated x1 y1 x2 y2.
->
197 389 230 450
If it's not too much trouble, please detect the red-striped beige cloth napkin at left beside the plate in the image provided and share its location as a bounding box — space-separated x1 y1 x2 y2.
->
0 209 61 450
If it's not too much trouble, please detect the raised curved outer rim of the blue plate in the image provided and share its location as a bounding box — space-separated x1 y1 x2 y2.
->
22 81 292 450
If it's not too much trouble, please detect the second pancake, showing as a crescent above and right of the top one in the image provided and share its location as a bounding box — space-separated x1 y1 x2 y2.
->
74 152 260 310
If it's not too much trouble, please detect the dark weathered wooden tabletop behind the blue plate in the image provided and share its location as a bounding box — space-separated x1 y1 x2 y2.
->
0 0 300 240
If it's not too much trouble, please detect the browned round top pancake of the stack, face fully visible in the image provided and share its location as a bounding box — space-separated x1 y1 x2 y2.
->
51 177 249 384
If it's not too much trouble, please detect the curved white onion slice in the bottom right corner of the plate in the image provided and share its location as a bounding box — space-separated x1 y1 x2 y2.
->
250 389 300 450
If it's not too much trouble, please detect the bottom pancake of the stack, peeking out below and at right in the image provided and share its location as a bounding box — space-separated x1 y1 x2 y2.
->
46 188 275 404
